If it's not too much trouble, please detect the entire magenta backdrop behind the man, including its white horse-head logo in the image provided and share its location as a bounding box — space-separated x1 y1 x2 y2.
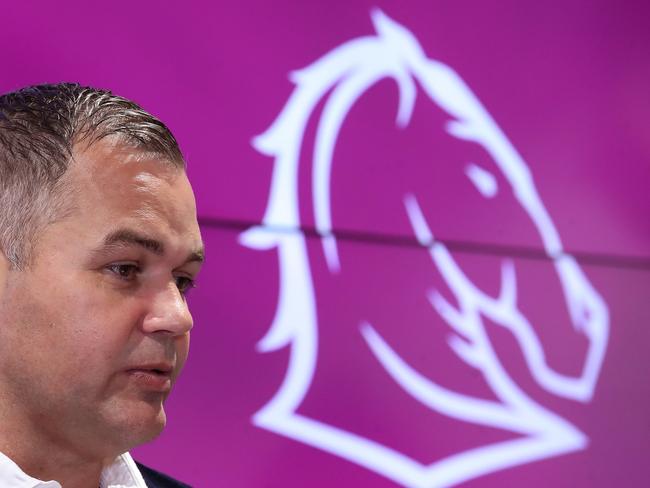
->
0 0 650 488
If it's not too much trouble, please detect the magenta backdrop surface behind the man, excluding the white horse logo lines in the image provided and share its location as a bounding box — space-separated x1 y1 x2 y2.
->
0 0 650 487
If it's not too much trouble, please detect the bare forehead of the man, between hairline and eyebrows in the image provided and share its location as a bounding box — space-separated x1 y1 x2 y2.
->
66 138 201 247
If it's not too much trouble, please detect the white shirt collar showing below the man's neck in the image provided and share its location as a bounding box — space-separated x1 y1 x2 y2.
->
0 452 147 488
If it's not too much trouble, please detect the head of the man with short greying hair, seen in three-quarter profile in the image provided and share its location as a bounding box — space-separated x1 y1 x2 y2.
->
0 84 203 458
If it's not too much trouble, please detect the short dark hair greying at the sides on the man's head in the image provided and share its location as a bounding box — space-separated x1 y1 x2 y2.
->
0 83 185 269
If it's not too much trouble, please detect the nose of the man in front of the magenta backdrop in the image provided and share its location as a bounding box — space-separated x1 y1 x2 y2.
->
142 282 193 335
